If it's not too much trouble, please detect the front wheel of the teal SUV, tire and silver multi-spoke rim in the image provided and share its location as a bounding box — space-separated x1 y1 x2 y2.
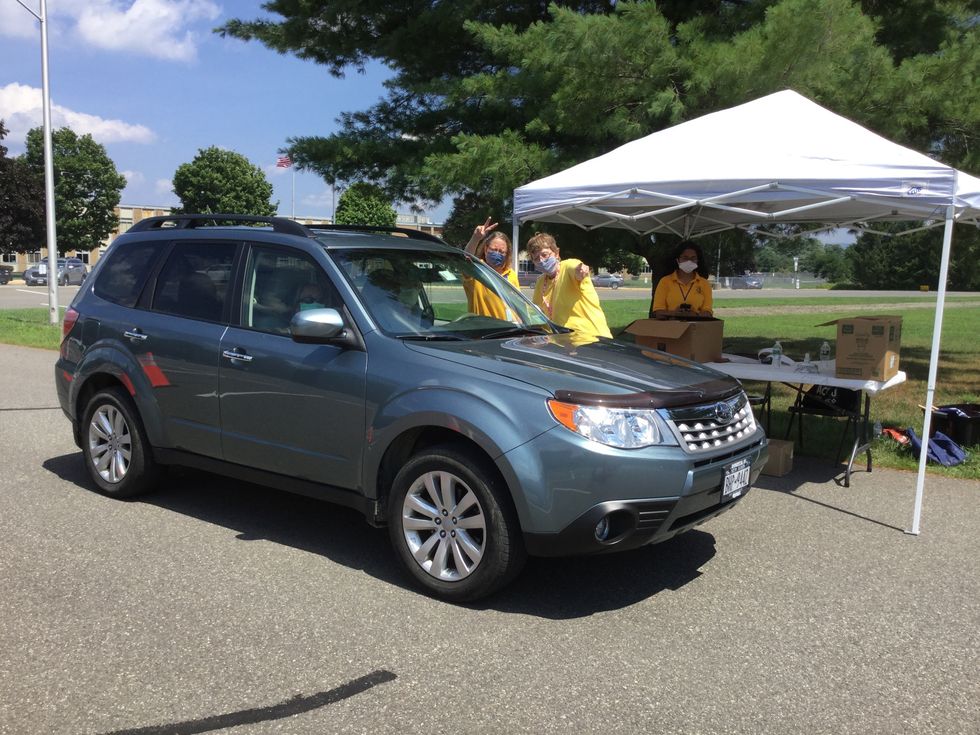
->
388 445 527 602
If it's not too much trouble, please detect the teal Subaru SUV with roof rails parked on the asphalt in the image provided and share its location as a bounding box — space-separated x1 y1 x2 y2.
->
55 215 767 601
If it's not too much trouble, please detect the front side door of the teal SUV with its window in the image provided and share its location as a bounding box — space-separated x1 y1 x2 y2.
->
218 245 367 489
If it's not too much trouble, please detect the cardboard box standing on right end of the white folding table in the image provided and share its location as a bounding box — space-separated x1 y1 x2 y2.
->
817 316 902 382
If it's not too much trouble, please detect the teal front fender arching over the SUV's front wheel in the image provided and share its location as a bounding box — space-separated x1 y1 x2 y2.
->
362 386 555 528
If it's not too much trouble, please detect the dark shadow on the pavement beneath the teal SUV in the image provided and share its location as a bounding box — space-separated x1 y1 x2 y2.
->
43 452 715 619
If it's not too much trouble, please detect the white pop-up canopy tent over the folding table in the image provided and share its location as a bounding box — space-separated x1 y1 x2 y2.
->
514 90 980 534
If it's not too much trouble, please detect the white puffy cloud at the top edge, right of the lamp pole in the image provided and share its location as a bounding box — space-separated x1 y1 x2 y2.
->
76 0 221 61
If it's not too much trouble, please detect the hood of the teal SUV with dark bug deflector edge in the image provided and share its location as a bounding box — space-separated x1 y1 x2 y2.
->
407 333 741 407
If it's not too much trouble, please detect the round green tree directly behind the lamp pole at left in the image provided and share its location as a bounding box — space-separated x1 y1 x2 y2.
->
24 128 126 253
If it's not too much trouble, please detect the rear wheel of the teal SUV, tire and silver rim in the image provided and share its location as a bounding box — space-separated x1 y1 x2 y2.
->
82 388 159 498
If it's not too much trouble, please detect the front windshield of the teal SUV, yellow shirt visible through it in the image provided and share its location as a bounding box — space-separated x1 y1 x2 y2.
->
329 248 564 340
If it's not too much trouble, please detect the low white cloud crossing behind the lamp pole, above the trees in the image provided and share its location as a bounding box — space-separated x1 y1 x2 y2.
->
0 82 156 150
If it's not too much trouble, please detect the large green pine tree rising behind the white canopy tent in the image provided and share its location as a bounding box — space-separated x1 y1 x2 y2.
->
220 0 980 278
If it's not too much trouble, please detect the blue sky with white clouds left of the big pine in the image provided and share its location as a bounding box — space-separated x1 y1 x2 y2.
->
0 0 448 222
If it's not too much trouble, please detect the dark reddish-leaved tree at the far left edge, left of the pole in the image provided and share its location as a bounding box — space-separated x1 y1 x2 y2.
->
0 120 44 253
